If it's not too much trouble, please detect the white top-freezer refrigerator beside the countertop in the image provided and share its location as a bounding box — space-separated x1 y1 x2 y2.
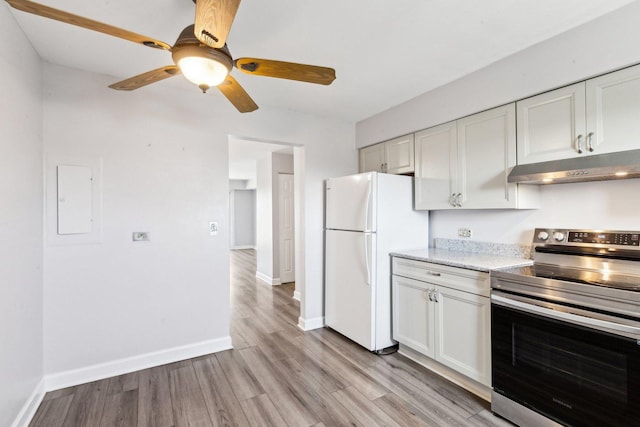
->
325 172 429 351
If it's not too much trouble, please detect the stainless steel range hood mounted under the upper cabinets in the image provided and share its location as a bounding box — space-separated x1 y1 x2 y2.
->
508 150 640 184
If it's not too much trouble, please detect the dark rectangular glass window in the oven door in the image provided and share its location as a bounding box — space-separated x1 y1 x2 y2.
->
512 324 628 405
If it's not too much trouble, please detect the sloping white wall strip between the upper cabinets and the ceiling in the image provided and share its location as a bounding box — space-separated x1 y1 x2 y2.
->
356 2 640 147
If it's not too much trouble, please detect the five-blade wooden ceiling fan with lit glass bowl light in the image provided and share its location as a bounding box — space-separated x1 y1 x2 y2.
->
5 0 336 113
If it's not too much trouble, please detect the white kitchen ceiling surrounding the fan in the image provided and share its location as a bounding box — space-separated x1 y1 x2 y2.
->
7 0 632 122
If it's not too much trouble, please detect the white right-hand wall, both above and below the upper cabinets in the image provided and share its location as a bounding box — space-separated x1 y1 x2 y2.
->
356 2 640 244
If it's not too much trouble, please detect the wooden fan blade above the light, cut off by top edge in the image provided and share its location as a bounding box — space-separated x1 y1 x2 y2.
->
194 0 240 48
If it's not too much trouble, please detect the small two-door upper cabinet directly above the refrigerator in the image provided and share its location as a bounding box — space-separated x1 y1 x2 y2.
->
360 134 414 174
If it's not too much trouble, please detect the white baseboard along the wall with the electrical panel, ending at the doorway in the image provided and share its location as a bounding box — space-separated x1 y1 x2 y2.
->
45 336 232 391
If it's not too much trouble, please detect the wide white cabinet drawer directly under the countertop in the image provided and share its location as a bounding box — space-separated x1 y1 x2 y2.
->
392 257 490 297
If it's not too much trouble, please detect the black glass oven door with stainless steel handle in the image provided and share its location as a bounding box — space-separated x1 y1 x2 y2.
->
491 291 640 426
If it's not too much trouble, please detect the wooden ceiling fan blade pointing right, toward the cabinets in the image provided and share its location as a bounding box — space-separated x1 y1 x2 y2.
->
235 58 336 85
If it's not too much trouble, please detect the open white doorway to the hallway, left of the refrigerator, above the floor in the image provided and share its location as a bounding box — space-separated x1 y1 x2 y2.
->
229 136 304 306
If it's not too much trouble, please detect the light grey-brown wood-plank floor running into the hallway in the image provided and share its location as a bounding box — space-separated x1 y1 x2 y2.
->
31 250 510 427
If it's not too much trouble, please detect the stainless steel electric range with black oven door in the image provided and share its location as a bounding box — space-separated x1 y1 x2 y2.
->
491 229 640 426
